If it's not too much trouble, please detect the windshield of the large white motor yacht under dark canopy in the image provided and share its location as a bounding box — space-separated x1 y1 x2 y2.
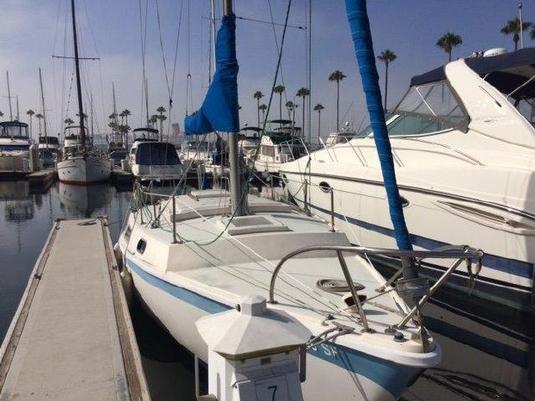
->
388 81 469 136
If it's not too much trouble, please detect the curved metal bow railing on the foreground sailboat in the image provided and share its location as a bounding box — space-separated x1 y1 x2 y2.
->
269 245 484 331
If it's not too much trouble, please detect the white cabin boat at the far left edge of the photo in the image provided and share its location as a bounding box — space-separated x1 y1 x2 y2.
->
0 121 36 176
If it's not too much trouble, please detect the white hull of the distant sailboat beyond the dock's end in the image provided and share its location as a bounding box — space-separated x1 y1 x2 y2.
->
57 156 111 185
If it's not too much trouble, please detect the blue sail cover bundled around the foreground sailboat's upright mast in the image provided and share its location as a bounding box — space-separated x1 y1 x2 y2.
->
184 14 240 135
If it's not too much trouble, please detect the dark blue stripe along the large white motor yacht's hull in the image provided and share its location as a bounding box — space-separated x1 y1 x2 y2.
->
300 196 533 279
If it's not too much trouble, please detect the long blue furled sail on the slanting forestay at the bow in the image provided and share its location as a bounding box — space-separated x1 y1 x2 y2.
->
346 0 412 250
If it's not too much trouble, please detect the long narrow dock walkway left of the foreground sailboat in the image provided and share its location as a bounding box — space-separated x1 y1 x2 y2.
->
0 218 150 401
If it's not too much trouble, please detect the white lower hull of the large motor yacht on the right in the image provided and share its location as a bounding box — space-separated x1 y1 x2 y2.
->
281 167 535 309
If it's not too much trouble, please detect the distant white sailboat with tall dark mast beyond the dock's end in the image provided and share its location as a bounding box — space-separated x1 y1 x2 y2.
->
57 0 111 185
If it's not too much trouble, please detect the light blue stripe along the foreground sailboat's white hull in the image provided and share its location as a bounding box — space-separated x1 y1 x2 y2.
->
126 258 423 399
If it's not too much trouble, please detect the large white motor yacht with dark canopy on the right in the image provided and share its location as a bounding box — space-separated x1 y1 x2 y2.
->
281 48 535 308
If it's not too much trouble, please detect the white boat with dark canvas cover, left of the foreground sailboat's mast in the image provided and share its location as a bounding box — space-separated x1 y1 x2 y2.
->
128 128 185 182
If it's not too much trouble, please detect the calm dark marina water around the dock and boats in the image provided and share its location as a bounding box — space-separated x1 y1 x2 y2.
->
0 182 535 401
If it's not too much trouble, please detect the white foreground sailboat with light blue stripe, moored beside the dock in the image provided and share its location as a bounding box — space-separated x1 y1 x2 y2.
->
116 0 482 401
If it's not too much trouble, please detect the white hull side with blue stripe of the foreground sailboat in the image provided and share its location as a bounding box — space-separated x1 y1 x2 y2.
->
120 253 424 401
